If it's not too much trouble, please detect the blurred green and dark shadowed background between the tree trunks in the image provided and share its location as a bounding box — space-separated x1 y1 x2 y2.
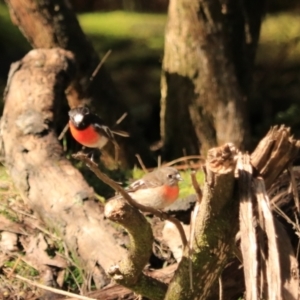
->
0 0 300 144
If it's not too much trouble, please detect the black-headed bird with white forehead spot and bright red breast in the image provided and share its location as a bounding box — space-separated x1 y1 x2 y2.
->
69 106 129 156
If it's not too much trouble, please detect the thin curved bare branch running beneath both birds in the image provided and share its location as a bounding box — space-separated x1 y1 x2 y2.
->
73 152 187 247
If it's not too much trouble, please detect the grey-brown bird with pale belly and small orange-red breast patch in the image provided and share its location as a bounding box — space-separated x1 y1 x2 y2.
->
113 167 182 209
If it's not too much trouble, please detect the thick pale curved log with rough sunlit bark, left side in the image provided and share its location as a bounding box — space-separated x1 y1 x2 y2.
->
1 49 125 287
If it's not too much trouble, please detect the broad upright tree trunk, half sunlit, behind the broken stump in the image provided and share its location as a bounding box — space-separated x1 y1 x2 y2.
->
161 0 263 157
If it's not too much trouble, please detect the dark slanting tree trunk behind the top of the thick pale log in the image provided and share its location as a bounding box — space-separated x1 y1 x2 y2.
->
6 0 155 166
